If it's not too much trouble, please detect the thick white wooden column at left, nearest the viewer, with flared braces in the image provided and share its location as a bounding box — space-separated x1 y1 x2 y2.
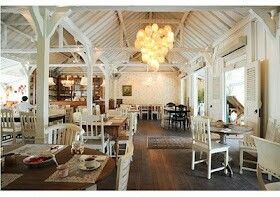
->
24 6 70 143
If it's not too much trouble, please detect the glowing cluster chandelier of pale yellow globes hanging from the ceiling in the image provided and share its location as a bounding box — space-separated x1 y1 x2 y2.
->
134 24 174 71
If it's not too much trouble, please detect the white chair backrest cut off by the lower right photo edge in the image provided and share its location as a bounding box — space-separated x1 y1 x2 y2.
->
253 136 280 179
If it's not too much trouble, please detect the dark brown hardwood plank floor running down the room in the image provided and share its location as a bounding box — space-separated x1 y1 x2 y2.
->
98 120 258 190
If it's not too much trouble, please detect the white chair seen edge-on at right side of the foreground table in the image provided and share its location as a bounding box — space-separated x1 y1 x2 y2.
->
116 143 134 191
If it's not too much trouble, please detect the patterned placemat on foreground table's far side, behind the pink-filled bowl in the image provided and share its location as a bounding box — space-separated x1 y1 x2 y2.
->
9 144 66 156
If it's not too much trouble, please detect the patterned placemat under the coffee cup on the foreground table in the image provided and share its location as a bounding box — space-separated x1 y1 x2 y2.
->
45 155 109 183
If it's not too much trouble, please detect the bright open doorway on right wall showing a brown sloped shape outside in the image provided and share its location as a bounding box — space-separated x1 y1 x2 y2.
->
224 67 245 124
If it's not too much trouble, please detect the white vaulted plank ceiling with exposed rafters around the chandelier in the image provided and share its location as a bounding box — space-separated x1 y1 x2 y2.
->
1 7 276 76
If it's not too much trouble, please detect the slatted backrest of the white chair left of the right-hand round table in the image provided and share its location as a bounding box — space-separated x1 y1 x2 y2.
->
191 116 211 149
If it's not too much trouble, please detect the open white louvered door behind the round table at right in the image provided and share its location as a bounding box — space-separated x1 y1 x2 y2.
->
245 61 262 136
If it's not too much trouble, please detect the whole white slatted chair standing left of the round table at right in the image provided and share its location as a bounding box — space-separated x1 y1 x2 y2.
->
191 116 229 179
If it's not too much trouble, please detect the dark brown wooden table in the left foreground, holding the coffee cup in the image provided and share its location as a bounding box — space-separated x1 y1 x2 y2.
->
2 146 115 190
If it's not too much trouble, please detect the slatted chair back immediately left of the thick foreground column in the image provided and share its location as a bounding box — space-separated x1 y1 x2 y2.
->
19 112 37 143
